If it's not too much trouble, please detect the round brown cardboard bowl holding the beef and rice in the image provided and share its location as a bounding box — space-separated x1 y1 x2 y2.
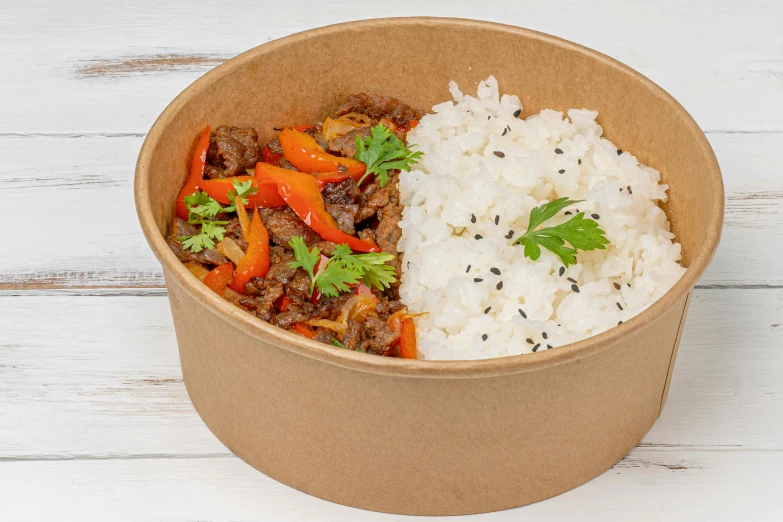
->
135 18 723 515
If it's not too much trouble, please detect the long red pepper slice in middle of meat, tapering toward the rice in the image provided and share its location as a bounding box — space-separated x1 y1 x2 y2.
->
256 163 380 252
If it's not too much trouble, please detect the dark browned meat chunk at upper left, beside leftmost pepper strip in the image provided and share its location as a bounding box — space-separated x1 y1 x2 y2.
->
205 126 261 179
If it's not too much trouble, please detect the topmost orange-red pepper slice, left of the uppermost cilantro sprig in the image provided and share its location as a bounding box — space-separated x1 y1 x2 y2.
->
278 127 367 181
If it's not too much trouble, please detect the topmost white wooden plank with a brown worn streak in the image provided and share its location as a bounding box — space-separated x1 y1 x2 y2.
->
0 0 783 133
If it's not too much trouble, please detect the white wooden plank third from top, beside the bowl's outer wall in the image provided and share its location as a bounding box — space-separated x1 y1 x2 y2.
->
0 289 783 458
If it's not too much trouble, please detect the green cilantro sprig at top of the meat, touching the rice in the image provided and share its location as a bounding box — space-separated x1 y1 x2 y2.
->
354 123 423 187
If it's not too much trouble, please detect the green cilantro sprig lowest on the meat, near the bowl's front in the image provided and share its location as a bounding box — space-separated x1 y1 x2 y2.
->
288 236 396 297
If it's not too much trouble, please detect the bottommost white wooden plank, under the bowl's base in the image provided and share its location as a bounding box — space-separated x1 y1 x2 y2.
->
0 448 783 522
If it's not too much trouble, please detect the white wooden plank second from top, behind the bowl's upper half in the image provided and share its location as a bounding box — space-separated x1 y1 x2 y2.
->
0 128 783 289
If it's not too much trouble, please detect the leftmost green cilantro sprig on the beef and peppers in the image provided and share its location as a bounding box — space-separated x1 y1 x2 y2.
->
177 179 258 253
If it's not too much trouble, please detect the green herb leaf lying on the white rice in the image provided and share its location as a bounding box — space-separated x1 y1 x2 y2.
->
514 198 609 267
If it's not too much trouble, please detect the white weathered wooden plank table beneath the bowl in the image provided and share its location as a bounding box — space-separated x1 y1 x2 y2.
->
0 0 783 522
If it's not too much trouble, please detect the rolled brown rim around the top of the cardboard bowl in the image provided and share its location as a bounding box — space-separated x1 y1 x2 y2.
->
134 17 724 378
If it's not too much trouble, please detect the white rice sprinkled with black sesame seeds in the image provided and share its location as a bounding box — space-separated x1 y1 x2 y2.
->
398 77 685 359
